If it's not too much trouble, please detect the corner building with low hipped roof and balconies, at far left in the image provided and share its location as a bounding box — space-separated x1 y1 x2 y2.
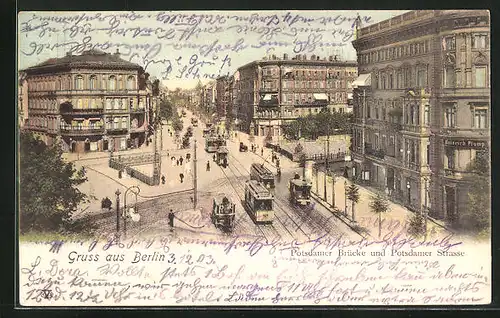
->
25 50 150 152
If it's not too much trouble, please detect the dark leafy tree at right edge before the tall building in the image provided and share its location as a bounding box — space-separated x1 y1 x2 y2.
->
459 151 491 235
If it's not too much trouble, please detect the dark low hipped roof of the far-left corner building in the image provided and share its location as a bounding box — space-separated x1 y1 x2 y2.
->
25 50 142 72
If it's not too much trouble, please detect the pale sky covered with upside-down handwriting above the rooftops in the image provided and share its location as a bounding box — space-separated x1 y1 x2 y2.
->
17 10 407 89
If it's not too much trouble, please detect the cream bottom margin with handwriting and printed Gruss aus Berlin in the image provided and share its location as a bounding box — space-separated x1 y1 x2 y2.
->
20 237 490 306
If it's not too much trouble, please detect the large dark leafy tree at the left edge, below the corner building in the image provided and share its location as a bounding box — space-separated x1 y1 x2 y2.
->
19 132 93 234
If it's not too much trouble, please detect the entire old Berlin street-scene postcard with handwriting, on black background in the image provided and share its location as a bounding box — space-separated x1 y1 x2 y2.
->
16 10 492 308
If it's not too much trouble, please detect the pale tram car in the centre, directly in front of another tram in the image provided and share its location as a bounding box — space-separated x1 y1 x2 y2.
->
244 180 274 224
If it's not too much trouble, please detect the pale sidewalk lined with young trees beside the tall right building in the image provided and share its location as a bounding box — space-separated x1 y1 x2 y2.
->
312 171 451 240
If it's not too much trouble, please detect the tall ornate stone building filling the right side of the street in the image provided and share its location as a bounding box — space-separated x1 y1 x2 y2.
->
352 10 490 226
